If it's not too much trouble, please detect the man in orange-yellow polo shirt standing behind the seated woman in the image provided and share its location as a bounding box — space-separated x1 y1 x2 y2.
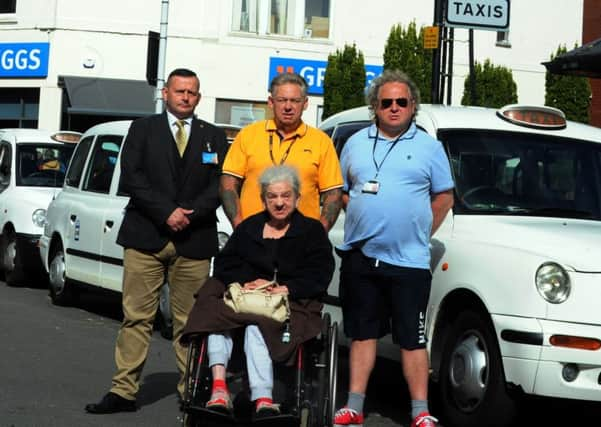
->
220 73 343 231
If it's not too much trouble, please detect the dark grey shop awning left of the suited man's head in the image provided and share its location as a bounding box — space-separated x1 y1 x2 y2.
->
59 76 155 117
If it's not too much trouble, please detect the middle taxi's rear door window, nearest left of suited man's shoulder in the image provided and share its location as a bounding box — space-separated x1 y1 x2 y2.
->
83 135 123 194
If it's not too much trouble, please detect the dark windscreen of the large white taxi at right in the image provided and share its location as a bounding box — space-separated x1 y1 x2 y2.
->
438 129 601 220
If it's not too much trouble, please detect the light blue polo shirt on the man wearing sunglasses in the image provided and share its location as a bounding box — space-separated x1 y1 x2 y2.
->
339 123 454 269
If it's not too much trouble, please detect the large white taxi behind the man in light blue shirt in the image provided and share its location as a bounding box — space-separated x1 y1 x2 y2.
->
320 105 601 427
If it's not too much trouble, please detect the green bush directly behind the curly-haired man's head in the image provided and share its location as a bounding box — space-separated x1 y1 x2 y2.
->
384 22 432 103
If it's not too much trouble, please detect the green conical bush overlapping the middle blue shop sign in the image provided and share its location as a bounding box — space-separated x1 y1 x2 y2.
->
321 44 365 119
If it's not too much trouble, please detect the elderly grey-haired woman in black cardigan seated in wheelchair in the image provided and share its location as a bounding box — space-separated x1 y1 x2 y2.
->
182 165 334 419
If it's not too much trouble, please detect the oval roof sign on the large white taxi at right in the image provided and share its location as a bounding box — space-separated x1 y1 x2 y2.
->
497 104 567 130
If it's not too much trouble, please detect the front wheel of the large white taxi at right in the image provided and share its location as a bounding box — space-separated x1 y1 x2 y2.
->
439 311 517 427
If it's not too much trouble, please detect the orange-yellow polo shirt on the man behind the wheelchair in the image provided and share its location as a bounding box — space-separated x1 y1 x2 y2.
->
223 120 343 219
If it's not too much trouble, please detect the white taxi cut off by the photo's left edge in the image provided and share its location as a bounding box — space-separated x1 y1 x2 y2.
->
0 129 81 285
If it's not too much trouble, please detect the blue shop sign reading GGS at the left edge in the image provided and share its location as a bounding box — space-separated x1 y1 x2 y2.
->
0 43 50 77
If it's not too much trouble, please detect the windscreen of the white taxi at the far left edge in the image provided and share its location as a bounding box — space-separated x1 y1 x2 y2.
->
15 143 75 187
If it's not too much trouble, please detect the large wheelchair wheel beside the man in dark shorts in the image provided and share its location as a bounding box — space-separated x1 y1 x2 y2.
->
301 313 338 427
